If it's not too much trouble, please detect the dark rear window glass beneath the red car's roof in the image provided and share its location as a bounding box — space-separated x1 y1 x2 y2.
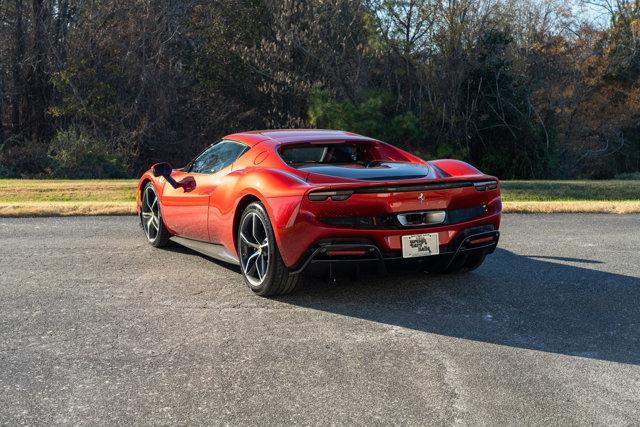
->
280 143 376 166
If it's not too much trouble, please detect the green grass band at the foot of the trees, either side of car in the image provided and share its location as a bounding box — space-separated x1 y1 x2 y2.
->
0 179 640 203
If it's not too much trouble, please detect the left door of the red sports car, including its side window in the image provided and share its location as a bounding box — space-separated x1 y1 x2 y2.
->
163 140 248 242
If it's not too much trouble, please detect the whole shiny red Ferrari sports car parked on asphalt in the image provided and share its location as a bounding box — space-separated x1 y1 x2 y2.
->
137 130 502 296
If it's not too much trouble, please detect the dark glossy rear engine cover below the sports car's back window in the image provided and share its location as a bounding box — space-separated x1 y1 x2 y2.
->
298 162 436 183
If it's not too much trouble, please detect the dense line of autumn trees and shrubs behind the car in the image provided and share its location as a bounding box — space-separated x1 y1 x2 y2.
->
0 0 640 178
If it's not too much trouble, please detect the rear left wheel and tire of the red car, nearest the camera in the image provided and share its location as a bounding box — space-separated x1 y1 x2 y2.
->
237 202 300 296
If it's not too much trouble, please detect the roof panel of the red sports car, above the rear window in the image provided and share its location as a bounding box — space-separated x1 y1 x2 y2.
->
224 129 376 147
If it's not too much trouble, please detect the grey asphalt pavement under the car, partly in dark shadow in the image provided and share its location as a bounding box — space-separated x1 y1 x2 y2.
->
0 215 640 424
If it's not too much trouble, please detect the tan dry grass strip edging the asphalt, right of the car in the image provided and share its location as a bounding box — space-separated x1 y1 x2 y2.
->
502 200 640 214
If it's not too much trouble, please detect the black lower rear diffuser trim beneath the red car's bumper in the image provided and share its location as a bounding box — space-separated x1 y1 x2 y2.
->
293 225 500 274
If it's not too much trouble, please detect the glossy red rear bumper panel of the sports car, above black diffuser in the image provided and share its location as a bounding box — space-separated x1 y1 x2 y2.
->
268 186 502 269
